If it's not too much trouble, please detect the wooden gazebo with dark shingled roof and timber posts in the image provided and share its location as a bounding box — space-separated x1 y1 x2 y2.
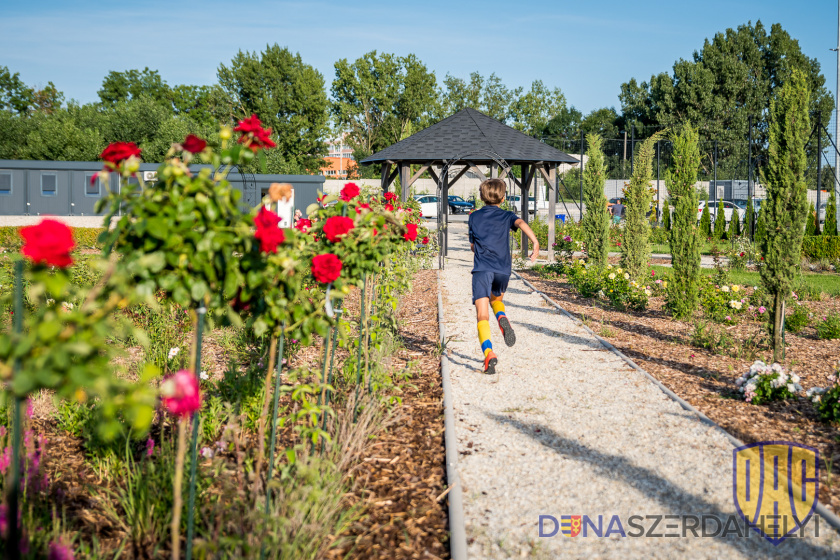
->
360 108 578 261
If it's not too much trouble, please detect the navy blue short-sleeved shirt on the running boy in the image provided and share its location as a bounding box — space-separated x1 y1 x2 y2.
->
469 205 519 274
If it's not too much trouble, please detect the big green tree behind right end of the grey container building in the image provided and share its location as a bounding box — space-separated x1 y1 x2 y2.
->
218 43 329 172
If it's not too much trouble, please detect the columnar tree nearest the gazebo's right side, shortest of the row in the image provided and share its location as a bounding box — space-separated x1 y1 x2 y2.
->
580 134 610 266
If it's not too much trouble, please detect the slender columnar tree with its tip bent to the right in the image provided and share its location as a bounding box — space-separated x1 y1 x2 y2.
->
621 127 663 278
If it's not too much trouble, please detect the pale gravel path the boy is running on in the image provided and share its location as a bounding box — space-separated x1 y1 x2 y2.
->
442 225 840 560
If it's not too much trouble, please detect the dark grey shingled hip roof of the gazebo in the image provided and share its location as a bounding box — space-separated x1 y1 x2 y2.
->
361 108 578 165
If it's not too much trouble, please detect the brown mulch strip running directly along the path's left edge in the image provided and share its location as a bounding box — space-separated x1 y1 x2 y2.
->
327 270 449 559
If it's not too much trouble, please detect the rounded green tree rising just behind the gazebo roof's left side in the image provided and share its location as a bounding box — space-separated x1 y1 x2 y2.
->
331 51 437 171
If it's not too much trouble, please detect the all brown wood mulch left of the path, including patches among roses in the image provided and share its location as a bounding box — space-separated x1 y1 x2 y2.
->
28 270 449 559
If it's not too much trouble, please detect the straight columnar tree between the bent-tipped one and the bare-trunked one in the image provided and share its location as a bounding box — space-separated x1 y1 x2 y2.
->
665 125 702 319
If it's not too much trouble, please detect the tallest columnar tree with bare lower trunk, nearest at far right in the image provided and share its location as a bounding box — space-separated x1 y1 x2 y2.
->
759 70 811 362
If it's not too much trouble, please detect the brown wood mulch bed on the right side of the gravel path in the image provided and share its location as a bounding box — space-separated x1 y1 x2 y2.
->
521 271 840 513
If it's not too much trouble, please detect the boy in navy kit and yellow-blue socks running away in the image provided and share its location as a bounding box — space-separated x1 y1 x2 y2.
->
469 179 540 374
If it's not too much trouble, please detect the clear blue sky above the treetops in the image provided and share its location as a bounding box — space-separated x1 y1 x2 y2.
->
0 0 837 113
